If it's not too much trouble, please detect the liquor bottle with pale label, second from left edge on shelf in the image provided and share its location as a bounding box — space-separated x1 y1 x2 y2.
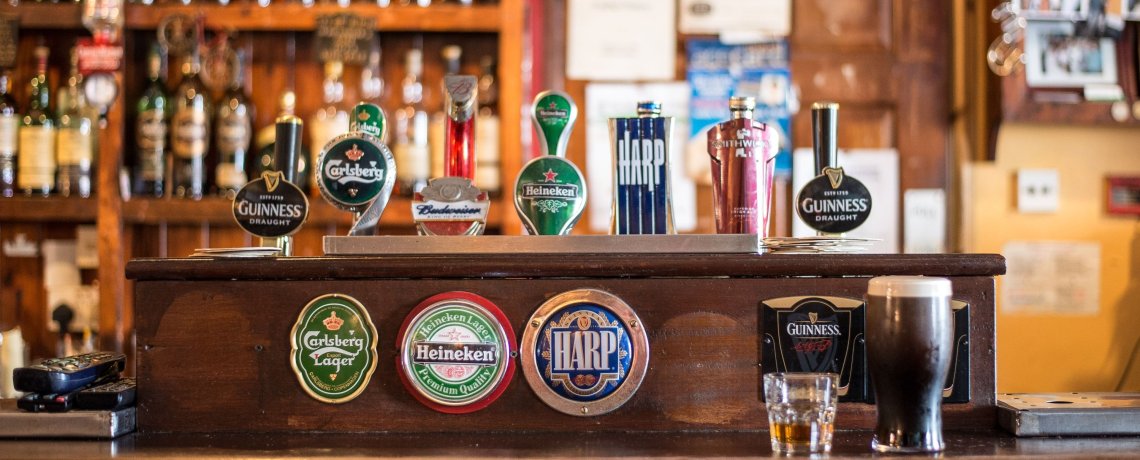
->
16 46 56 196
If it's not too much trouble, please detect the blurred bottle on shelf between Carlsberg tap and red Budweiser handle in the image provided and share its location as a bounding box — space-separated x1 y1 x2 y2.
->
393 49 431 197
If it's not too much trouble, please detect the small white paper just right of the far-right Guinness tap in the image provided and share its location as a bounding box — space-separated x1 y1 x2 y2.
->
903 189 946 254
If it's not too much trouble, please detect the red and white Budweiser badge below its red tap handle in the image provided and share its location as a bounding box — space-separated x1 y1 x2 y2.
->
412 178 491 235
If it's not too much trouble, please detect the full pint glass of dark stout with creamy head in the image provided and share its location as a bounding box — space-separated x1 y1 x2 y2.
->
866 277 953 452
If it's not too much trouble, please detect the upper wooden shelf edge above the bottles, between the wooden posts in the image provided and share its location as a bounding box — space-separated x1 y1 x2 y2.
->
125 2 502 32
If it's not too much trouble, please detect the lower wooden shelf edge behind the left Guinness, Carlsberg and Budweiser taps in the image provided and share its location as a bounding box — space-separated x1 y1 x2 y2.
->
121 197 503 228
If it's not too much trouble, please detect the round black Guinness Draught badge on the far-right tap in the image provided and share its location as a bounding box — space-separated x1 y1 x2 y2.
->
796 167 871 233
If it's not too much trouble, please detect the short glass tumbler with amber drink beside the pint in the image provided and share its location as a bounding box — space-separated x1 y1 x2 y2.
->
764 372 839 454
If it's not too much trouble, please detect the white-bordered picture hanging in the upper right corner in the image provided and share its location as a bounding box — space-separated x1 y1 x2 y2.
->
1025 20 1117 88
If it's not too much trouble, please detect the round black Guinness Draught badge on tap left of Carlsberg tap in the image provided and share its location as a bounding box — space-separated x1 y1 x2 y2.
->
234 171 309 238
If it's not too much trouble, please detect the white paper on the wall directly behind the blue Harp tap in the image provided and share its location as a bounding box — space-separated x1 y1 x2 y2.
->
586 82 697 232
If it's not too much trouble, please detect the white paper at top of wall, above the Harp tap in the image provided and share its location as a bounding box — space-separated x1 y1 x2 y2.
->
567 0 677 81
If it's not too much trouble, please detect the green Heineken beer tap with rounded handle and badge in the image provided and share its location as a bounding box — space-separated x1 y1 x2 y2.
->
514 91 586 235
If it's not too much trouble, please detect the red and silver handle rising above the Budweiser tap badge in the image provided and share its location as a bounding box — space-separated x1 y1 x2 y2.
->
443 75 479 181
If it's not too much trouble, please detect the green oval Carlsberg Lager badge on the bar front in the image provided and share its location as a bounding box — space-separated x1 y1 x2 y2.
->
290 294 376 404
